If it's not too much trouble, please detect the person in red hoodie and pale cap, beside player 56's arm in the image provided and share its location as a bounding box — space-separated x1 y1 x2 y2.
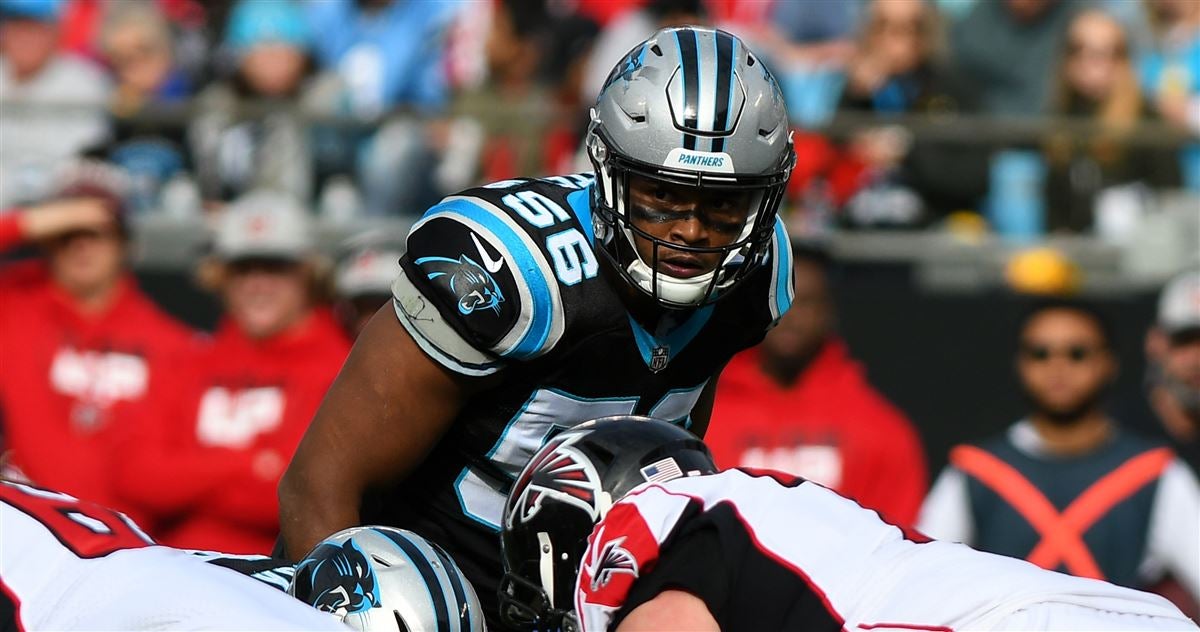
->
120 191 349 553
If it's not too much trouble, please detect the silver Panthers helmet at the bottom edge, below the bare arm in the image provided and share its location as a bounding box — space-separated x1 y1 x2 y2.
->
288 526 487 632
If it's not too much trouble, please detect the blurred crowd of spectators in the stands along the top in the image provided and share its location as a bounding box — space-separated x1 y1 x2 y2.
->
0 0 1200 237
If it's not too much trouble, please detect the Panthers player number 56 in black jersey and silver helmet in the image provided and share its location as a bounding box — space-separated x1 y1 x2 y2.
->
280 26 794 628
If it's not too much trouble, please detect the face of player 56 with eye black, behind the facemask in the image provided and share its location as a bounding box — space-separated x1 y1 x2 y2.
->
629 176 750 278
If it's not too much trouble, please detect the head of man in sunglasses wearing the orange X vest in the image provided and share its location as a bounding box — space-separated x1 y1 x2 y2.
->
1016 309 1116 420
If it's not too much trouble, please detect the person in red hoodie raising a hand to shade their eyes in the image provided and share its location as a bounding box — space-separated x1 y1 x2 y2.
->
0 163 192 525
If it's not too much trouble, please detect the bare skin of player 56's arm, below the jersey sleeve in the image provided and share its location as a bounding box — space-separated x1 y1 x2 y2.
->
280 305 482 560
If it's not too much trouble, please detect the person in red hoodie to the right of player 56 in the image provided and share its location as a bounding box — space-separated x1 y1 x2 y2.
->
704 248 928 526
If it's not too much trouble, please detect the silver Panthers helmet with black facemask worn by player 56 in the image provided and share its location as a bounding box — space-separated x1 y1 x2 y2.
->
587 26 796 308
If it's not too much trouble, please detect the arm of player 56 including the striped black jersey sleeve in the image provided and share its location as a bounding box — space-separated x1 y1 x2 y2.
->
280 198 540 559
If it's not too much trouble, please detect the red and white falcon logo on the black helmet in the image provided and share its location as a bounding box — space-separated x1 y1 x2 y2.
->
508 435 600 525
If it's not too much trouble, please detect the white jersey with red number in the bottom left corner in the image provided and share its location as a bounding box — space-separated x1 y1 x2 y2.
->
0 482 346 631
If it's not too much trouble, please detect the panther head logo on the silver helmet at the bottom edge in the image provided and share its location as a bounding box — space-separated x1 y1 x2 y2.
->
295 540 379 615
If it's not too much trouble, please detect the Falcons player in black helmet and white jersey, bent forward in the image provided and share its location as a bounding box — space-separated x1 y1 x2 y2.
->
500 417 1198 632
